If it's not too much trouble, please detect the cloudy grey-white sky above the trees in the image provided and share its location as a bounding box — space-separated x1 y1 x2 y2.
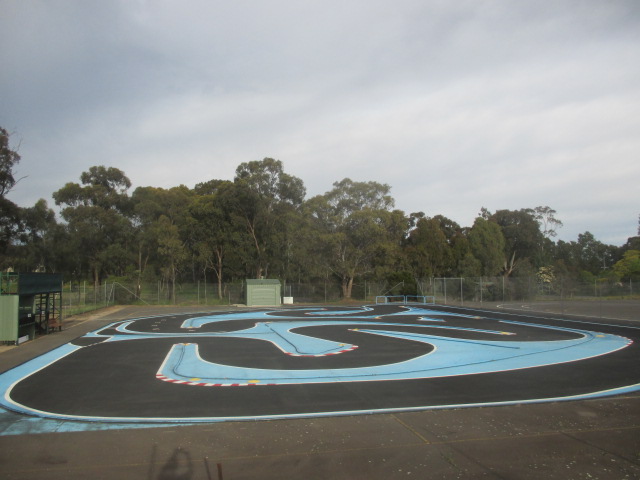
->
0 0 640 245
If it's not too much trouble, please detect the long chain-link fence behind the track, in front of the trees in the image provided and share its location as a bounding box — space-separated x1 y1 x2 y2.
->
62 277 640 316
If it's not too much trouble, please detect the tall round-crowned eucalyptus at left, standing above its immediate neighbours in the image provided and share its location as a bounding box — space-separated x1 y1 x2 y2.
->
53 166 133 285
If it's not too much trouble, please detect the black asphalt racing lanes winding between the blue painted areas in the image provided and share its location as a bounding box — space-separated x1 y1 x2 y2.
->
5 305 640 419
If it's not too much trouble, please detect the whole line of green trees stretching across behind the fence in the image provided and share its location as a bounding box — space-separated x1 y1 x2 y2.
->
0 128 640 298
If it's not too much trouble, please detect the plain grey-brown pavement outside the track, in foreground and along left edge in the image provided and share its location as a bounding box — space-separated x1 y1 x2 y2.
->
0 307 640 480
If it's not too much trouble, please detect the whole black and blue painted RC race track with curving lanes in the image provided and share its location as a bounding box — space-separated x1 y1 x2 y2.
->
0 305 640 424
